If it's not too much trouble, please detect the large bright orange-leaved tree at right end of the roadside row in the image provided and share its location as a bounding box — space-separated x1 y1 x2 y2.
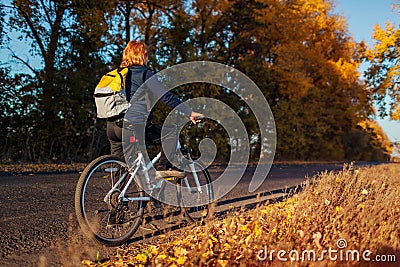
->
248 0 371 159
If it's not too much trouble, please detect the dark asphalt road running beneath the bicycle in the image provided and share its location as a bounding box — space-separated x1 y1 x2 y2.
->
0 164 356 266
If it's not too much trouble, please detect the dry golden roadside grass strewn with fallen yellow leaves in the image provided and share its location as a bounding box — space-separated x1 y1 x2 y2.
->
79 164 400 266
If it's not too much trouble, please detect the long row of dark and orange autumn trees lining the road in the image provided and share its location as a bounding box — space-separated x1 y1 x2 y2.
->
0 0 397 161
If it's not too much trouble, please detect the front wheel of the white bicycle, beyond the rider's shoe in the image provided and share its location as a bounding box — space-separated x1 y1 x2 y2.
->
178 162 214 222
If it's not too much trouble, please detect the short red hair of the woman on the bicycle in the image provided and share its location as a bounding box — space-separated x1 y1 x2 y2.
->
120 41 149 68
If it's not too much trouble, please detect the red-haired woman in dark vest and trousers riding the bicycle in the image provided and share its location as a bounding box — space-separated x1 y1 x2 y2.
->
107 41 203 177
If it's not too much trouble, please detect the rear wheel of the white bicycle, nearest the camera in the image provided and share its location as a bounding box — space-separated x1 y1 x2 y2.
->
75 155 144 246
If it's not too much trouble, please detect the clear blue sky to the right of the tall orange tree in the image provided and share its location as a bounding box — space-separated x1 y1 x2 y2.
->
333 0 400 142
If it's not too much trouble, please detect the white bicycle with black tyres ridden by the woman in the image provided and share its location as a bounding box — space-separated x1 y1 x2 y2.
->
75 121 214 246
